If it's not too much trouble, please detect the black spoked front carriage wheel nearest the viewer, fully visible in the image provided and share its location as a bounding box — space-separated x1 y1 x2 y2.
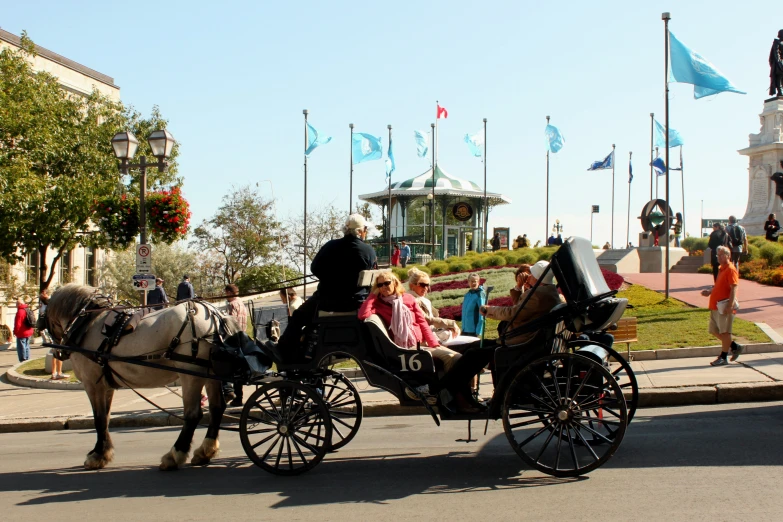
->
239 381 332 475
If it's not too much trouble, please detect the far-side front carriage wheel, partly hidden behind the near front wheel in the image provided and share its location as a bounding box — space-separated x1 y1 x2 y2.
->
310 371 363 451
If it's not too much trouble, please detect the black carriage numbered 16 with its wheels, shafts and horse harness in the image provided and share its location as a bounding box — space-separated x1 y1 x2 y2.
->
43 238 638 477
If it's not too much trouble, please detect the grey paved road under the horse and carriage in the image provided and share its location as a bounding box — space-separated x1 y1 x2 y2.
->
0 402 783 521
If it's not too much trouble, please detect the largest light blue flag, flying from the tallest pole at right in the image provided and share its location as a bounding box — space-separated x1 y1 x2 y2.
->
669 31 745 99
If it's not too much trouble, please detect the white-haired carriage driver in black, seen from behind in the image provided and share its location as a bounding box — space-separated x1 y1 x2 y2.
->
278 214 377 350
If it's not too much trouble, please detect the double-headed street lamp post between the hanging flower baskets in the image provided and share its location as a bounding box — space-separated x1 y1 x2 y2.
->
111 129 175 306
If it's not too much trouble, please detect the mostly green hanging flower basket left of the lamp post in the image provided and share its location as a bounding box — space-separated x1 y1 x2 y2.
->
93 194 139 250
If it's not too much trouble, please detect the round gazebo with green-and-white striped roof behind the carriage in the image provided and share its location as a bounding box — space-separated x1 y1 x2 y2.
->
359 165 511 262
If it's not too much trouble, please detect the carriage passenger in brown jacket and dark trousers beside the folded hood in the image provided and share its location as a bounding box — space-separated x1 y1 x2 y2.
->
429 261 562 413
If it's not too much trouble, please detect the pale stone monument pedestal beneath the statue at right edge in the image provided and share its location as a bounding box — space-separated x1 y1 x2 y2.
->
737 96 783 235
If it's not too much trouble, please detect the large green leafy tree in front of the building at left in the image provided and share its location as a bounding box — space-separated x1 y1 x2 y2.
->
0 33 180 290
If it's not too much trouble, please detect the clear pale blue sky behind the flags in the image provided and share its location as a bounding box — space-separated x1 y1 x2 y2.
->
0 0 783 244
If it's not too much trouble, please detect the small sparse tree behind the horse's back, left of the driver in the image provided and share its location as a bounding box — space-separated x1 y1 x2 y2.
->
192 185 280 283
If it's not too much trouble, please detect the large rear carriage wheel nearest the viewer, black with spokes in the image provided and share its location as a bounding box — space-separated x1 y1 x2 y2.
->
502 353 628 477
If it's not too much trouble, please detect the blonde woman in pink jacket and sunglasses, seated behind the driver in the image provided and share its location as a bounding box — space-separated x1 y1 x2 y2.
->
359 272 460 372
